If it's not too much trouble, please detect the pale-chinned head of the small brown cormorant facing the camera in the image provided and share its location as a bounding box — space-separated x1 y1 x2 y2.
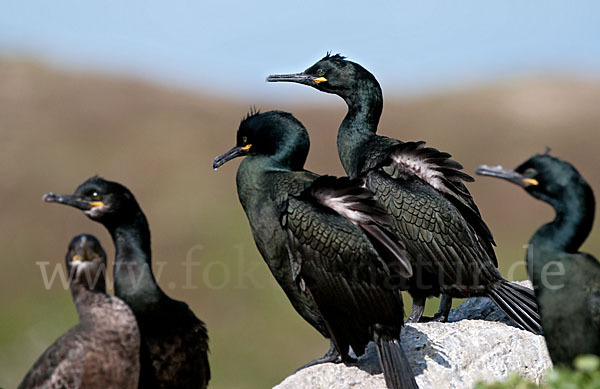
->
66 234 106 292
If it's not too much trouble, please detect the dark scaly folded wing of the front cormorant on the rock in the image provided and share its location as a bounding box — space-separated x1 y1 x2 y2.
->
282 186 403 355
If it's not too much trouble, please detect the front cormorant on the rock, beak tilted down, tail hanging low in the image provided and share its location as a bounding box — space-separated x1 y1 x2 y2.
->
213 111 416 388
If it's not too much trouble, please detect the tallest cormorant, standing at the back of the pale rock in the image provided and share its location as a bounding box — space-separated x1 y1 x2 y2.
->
267 54 540 332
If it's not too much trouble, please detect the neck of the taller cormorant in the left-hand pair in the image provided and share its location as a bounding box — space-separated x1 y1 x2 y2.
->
109 210 163 312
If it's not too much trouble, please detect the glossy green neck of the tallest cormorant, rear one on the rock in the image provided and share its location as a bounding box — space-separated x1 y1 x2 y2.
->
337 78 383 177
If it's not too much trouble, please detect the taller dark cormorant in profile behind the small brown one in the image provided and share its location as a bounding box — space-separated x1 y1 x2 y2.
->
44 176 210 389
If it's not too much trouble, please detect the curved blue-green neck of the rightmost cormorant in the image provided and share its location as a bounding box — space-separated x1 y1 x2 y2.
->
532 183 595 253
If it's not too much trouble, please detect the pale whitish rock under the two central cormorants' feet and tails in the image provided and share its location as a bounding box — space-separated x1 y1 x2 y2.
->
275 283 552 389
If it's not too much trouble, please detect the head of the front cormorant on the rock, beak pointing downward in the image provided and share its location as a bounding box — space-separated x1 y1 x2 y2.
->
213 111 310 170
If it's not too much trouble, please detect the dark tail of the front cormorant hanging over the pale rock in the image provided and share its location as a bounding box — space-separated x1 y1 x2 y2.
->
375 334 419 389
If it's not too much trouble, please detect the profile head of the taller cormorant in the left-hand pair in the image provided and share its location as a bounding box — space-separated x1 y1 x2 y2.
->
43 176 140 227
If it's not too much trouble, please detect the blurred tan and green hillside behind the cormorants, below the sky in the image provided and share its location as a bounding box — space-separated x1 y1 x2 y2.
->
0 58 600 388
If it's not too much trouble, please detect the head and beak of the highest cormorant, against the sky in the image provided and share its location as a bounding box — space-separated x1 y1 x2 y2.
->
267 53 381 99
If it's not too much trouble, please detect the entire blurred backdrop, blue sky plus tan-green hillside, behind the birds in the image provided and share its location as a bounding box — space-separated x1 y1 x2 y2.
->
0 0 600 389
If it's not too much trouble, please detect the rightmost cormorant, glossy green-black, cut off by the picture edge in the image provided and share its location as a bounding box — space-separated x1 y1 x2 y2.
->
476 154 600 365
